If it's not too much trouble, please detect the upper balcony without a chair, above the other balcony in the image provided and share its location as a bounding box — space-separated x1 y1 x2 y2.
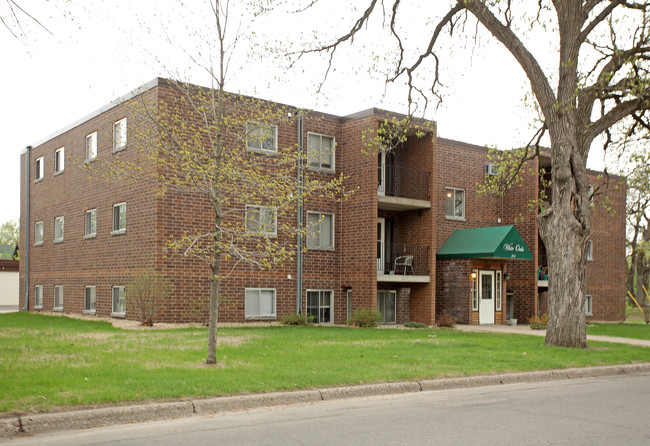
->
377 163 431 211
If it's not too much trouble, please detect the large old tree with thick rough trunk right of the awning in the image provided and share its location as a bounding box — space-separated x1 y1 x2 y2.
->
301 0 650 347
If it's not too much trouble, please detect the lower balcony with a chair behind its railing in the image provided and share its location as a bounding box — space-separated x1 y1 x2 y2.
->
377 242 431 283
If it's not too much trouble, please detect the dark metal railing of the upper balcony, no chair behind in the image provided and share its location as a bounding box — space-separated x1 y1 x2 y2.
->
377 165 430 200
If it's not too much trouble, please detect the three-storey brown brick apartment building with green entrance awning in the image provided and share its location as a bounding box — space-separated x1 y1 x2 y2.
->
20 79 626 324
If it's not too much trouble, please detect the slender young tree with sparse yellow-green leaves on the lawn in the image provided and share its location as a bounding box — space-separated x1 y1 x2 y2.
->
94 0 345 364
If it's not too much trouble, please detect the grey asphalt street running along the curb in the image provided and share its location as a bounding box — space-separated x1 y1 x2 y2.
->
6 375 650 446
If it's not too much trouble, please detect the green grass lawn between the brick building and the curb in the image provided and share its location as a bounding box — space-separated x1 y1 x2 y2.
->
0 313 650 413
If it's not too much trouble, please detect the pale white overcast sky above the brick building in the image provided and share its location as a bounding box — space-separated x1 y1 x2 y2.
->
0 0 603 222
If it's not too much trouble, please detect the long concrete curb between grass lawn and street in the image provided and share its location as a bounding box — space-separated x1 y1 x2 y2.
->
0 363 650 438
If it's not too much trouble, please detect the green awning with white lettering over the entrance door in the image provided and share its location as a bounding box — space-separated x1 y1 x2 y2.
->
436 225 533 260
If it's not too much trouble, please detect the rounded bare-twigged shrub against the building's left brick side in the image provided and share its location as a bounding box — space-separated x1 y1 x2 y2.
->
124 268 171 326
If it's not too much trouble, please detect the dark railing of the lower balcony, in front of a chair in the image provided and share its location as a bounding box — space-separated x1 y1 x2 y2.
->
377 242 429 276
